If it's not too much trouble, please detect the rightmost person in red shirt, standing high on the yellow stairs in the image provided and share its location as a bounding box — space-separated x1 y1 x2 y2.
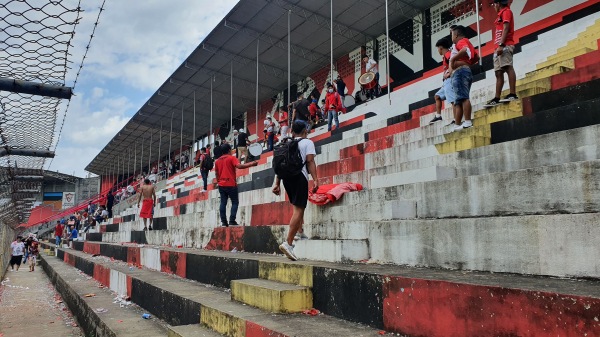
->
485 0 519 108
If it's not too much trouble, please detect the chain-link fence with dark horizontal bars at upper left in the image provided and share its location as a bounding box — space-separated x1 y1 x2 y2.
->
0 0 82 228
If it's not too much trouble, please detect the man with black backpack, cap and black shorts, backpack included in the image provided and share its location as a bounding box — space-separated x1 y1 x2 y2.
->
273 120 319 261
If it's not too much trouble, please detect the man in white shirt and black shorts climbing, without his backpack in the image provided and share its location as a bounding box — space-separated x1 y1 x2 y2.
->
272 120 319 261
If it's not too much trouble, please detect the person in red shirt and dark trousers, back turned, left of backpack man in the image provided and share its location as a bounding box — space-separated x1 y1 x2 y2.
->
215 144 258 227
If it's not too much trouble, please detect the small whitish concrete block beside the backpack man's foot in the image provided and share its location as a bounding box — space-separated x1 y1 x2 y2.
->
294 239 370 262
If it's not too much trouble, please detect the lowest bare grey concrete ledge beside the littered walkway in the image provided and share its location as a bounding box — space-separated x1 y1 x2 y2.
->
40 256 167 337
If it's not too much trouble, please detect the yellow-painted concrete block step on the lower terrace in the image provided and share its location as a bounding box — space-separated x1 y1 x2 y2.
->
231 278 313 313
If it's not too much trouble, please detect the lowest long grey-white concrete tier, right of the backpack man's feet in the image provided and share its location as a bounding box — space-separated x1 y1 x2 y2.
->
302 213 600 278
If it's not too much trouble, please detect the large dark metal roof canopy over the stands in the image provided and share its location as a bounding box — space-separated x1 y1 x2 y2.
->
86 0 441 175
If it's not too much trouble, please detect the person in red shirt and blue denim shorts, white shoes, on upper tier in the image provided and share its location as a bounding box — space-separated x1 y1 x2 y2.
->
450 26 477 131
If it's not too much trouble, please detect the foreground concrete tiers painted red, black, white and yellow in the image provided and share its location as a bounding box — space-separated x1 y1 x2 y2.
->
44 240 600 337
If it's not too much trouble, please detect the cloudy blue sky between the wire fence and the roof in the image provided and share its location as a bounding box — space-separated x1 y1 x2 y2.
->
46 0 237 177
